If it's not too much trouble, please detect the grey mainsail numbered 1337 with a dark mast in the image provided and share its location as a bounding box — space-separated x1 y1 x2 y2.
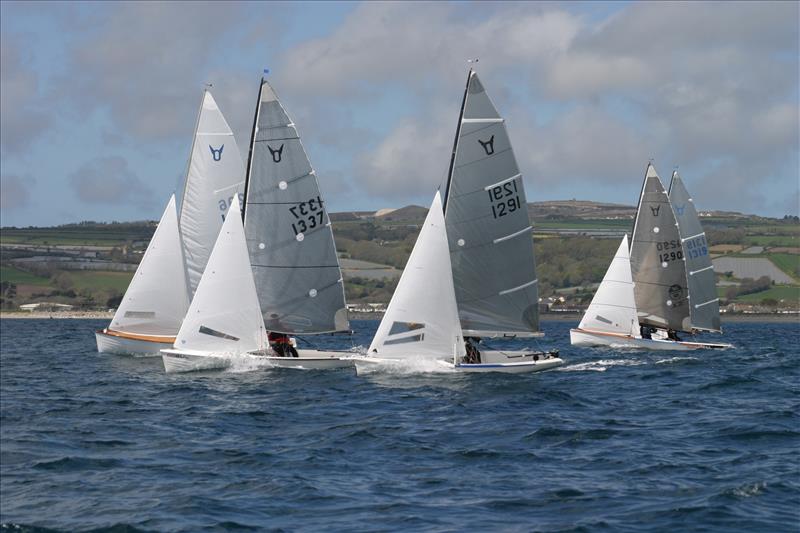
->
244 79 349 334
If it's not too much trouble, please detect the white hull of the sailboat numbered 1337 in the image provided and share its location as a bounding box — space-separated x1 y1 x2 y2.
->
161 349 354 374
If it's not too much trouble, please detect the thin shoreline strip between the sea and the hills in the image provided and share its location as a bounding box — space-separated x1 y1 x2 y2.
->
0 311 800 325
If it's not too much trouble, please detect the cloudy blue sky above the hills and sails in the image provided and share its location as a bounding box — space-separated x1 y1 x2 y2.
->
0 1 800 226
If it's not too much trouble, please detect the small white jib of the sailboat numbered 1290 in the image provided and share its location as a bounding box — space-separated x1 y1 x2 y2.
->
578 235 639 337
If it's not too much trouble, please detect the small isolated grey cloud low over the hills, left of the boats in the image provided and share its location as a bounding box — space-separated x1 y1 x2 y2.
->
67 156 153 207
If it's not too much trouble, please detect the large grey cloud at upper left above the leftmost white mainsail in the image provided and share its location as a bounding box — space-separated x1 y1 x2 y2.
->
64 2 248 140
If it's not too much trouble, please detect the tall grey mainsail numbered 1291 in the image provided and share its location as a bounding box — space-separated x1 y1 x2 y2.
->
445 71 539 336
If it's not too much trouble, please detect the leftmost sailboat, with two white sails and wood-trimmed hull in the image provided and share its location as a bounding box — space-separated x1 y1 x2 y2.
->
95 89 244 355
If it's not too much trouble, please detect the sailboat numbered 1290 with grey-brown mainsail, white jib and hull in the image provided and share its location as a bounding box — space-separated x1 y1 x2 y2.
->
570 164 730 351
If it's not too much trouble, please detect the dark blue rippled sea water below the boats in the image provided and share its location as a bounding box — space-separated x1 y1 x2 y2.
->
0 320 800 532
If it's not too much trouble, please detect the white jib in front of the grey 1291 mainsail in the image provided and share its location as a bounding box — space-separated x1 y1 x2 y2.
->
369 192 465 359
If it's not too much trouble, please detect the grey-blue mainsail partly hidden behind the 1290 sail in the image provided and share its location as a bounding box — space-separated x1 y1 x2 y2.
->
669 171 721 331
